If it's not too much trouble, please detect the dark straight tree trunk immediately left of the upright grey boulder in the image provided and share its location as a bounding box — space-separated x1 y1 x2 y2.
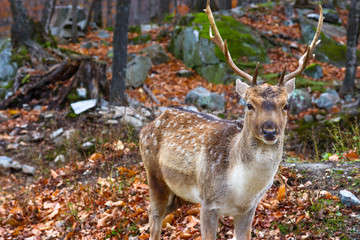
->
110 0 130 105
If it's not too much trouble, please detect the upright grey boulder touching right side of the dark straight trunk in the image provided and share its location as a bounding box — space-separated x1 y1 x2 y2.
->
125 55 152 88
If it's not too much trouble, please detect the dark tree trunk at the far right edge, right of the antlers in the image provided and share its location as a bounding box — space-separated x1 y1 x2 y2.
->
341 0 360 95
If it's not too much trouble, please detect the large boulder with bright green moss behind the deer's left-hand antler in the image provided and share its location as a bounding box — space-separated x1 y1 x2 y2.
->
168 13 269 83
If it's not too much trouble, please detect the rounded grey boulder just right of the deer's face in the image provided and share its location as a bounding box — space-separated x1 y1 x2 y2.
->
289 89 312 114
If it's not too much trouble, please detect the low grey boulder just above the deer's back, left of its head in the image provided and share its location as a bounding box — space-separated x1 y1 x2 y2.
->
185 87 226 112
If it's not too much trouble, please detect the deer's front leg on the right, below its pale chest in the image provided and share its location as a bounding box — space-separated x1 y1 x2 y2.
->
234 207 256 240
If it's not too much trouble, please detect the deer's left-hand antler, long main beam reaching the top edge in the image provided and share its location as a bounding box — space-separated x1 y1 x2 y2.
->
204 0 253 82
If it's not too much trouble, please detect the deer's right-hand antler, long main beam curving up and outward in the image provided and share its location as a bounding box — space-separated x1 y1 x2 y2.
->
282 5 324 85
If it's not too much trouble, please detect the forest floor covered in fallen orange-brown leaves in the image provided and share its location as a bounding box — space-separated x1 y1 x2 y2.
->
0 3 360 240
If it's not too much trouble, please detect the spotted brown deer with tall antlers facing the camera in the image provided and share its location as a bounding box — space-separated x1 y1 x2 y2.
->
139 0 323 240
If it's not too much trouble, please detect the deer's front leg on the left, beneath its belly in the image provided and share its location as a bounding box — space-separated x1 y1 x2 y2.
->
200 204 219 240
